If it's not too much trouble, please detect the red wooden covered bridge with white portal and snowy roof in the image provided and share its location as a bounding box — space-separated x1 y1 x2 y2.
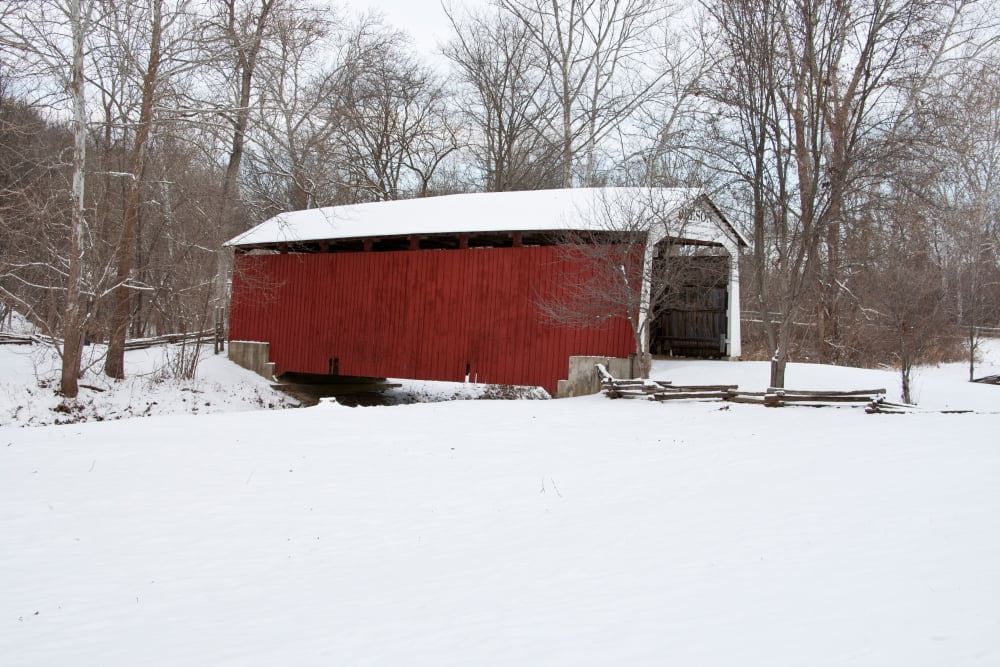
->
227 188 745 395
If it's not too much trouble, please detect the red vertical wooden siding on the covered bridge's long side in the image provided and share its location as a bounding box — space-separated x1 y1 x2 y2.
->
229 246 635 395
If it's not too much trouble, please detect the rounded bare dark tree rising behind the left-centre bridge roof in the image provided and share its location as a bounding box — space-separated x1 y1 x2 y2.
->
239 10 458 212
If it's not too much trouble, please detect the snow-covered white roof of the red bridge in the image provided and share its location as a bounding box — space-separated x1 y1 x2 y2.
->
226 188 745 247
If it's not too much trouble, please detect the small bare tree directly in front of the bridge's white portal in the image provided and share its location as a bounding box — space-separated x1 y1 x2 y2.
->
538 193 736 378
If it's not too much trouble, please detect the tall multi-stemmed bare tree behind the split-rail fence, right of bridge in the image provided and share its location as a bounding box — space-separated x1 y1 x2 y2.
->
706 0 984 387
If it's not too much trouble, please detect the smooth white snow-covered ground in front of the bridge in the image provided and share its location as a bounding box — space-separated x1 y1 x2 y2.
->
0 346 1000 667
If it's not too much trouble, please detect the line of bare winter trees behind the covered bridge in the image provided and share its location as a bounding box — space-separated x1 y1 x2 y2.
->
0 0 1000 397
